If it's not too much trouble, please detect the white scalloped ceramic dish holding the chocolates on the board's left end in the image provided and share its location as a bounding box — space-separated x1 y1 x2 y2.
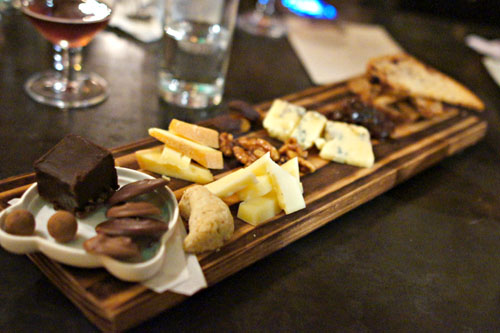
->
0 167 179 281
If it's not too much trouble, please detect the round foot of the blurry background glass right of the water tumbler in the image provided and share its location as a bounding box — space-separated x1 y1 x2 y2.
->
238 10 286 38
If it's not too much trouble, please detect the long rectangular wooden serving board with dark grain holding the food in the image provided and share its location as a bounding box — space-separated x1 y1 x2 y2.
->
0 83 487 331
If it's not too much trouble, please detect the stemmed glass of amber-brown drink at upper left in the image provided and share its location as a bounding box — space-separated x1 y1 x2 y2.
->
21 0 113 109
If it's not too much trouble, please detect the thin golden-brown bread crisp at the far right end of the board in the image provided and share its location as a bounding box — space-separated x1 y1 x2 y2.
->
367 53 484 111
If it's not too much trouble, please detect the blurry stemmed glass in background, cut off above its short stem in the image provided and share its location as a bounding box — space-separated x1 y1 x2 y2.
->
238 0 286 38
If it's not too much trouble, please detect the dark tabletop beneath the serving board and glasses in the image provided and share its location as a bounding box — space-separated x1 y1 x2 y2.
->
0 2 500 332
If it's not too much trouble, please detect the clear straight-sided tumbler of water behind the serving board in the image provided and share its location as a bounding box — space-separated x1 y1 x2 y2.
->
159 0 239 108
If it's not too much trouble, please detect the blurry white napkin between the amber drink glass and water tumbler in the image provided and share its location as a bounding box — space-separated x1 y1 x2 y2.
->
109 0 163 43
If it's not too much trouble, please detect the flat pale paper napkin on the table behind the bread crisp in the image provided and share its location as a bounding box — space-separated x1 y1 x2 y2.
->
287 16 402 84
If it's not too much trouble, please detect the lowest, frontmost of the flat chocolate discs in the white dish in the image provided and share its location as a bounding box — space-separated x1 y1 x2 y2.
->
83 234 141 259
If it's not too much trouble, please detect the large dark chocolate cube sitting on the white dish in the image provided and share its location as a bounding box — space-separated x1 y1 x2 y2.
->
34 134 118 215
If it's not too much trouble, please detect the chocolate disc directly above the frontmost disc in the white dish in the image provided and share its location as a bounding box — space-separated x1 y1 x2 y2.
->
95 217 168 238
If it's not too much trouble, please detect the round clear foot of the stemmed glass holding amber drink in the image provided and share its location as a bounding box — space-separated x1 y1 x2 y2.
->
24 71 108 109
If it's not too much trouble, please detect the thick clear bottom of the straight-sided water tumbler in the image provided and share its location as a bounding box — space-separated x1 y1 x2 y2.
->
159 73 224 109
